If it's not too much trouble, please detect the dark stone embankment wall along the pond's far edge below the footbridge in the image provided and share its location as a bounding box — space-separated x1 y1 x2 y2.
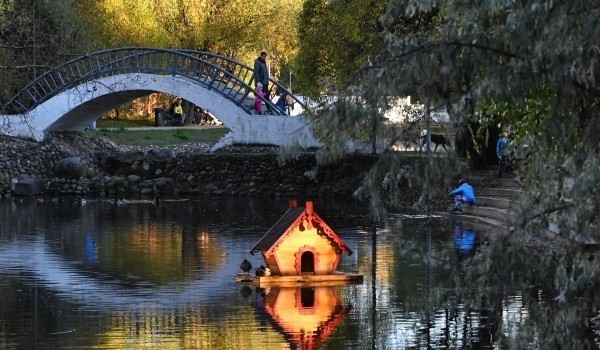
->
0 133 377 198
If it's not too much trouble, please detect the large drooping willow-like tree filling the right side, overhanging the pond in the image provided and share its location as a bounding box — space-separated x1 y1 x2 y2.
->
316 0 600 348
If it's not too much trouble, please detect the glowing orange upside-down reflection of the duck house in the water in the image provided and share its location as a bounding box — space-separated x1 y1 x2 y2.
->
256 287 349 350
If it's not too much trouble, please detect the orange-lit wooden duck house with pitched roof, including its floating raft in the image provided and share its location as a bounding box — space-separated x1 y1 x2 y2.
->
237 201 362 285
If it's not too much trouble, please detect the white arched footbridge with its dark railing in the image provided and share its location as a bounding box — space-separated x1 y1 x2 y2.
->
0 47 320 148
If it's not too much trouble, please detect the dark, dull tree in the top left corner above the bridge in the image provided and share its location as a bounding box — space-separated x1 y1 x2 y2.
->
0 0 97 109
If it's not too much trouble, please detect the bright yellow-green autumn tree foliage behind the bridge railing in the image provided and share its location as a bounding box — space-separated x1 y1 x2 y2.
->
77 0 302 76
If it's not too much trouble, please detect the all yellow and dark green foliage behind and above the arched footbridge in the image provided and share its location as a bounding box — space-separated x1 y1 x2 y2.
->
0 0 302 114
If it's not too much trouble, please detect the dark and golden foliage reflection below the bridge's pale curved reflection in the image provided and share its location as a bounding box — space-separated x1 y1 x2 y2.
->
0 275 296 350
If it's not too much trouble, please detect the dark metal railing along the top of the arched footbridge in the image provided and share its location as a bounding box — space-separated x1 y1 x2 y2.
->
3 47 302 115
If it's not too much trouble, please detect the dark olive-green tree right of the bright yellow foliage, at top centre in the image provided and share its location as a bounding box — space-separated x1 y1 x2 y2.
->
294 0 387 97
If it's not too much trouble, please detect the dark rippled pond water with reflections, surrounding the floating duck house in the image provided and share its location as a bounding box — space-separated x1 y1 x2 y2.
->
0 199 548 349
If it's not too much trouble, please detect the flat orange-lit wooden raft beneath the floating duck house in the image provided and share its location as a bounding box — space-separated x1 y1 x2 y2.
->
235 271 363 287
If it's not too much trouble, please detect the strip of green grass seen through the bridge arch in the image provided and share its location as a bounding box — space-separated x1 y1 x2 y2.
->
86 127 229 146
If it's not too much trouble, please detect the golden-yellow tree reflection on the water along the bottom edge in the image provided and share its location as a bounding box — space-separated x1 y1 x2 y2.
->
77 296 286 350
